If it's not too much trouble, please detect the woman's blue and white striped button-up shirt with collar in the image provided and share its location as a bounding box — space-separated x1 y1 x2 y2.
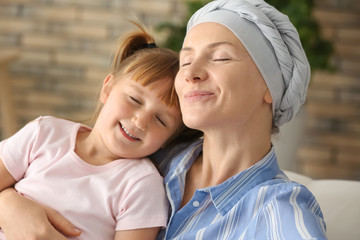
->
155 140 326 240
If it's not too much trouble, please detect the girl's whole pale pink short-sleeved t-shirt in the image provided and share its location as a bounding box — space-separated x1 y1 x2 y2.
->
0 117 168 240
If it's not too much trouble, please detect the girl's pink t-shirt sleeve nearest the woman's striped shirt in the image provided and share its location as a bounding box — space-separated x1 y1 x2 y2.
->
116 173 169 231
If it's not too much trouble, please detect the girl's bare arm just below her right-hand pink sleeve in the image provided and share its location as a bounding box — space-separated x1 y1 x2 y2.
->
114 227 160 240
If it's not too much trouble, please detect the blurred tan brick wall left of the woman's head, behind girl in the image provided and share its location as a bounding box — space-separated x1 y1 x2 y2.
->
0 0 185 129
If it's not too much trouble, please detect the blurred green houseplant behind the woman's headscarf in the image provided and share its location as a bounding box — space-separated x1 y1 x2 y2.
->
157 0 333 70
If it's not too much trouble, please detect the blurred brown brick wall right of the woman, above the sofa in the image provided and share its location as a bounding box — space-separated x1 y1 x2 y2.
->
298 0 360 180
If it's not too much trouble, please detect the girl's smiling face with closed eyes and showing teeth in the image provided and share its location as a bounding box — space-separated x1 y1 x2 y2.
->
94 75 181 158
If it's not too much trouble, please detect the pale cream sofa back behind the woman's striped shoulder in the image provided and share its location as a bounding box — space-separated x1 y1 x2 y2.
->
284 171 360 240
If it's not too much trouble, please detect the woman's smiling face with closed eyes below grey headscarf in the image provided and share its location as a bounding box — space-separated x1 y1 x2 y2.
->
175 23 271 131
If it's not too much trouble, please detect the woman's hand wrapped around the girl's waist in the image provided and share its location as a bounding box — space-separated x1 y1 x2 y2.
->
0 188 81 240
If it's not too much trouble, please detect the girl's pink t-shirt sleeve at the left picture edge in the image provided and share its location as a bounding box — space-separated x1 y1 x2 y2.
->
0 118 40 181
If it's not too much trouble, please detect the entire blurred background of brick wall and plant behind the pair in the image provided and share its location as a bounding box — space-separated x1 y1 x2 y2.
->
0 0 360 180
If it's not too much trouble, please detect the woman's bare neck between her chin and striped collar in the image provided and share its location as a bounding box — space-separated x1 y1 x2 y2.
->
197 124 271 187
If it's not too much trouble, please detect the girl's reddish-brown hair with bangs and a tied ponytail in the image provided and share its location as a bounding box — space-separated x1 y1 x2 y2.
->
91 21 180 123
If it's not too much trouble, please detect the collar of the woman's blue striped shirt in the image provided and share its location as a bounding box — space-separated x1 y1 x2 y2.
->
164 139 280 215
